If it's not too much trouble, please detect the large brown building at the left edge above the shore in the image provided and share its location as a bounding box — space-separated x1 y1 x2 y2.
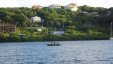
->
0 22 16 33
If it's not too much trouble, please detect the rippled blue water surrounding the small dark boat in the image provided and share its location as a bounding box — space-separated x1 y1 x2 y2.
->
0 40 113 64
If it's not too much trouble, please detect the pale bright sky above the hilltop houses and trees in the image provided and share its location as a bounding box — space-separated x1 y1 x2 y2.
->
0 0 113 8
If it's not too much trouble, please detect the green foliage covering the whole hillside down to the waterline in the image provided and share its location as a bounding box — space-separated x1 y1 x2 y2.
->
0 5 113 41
